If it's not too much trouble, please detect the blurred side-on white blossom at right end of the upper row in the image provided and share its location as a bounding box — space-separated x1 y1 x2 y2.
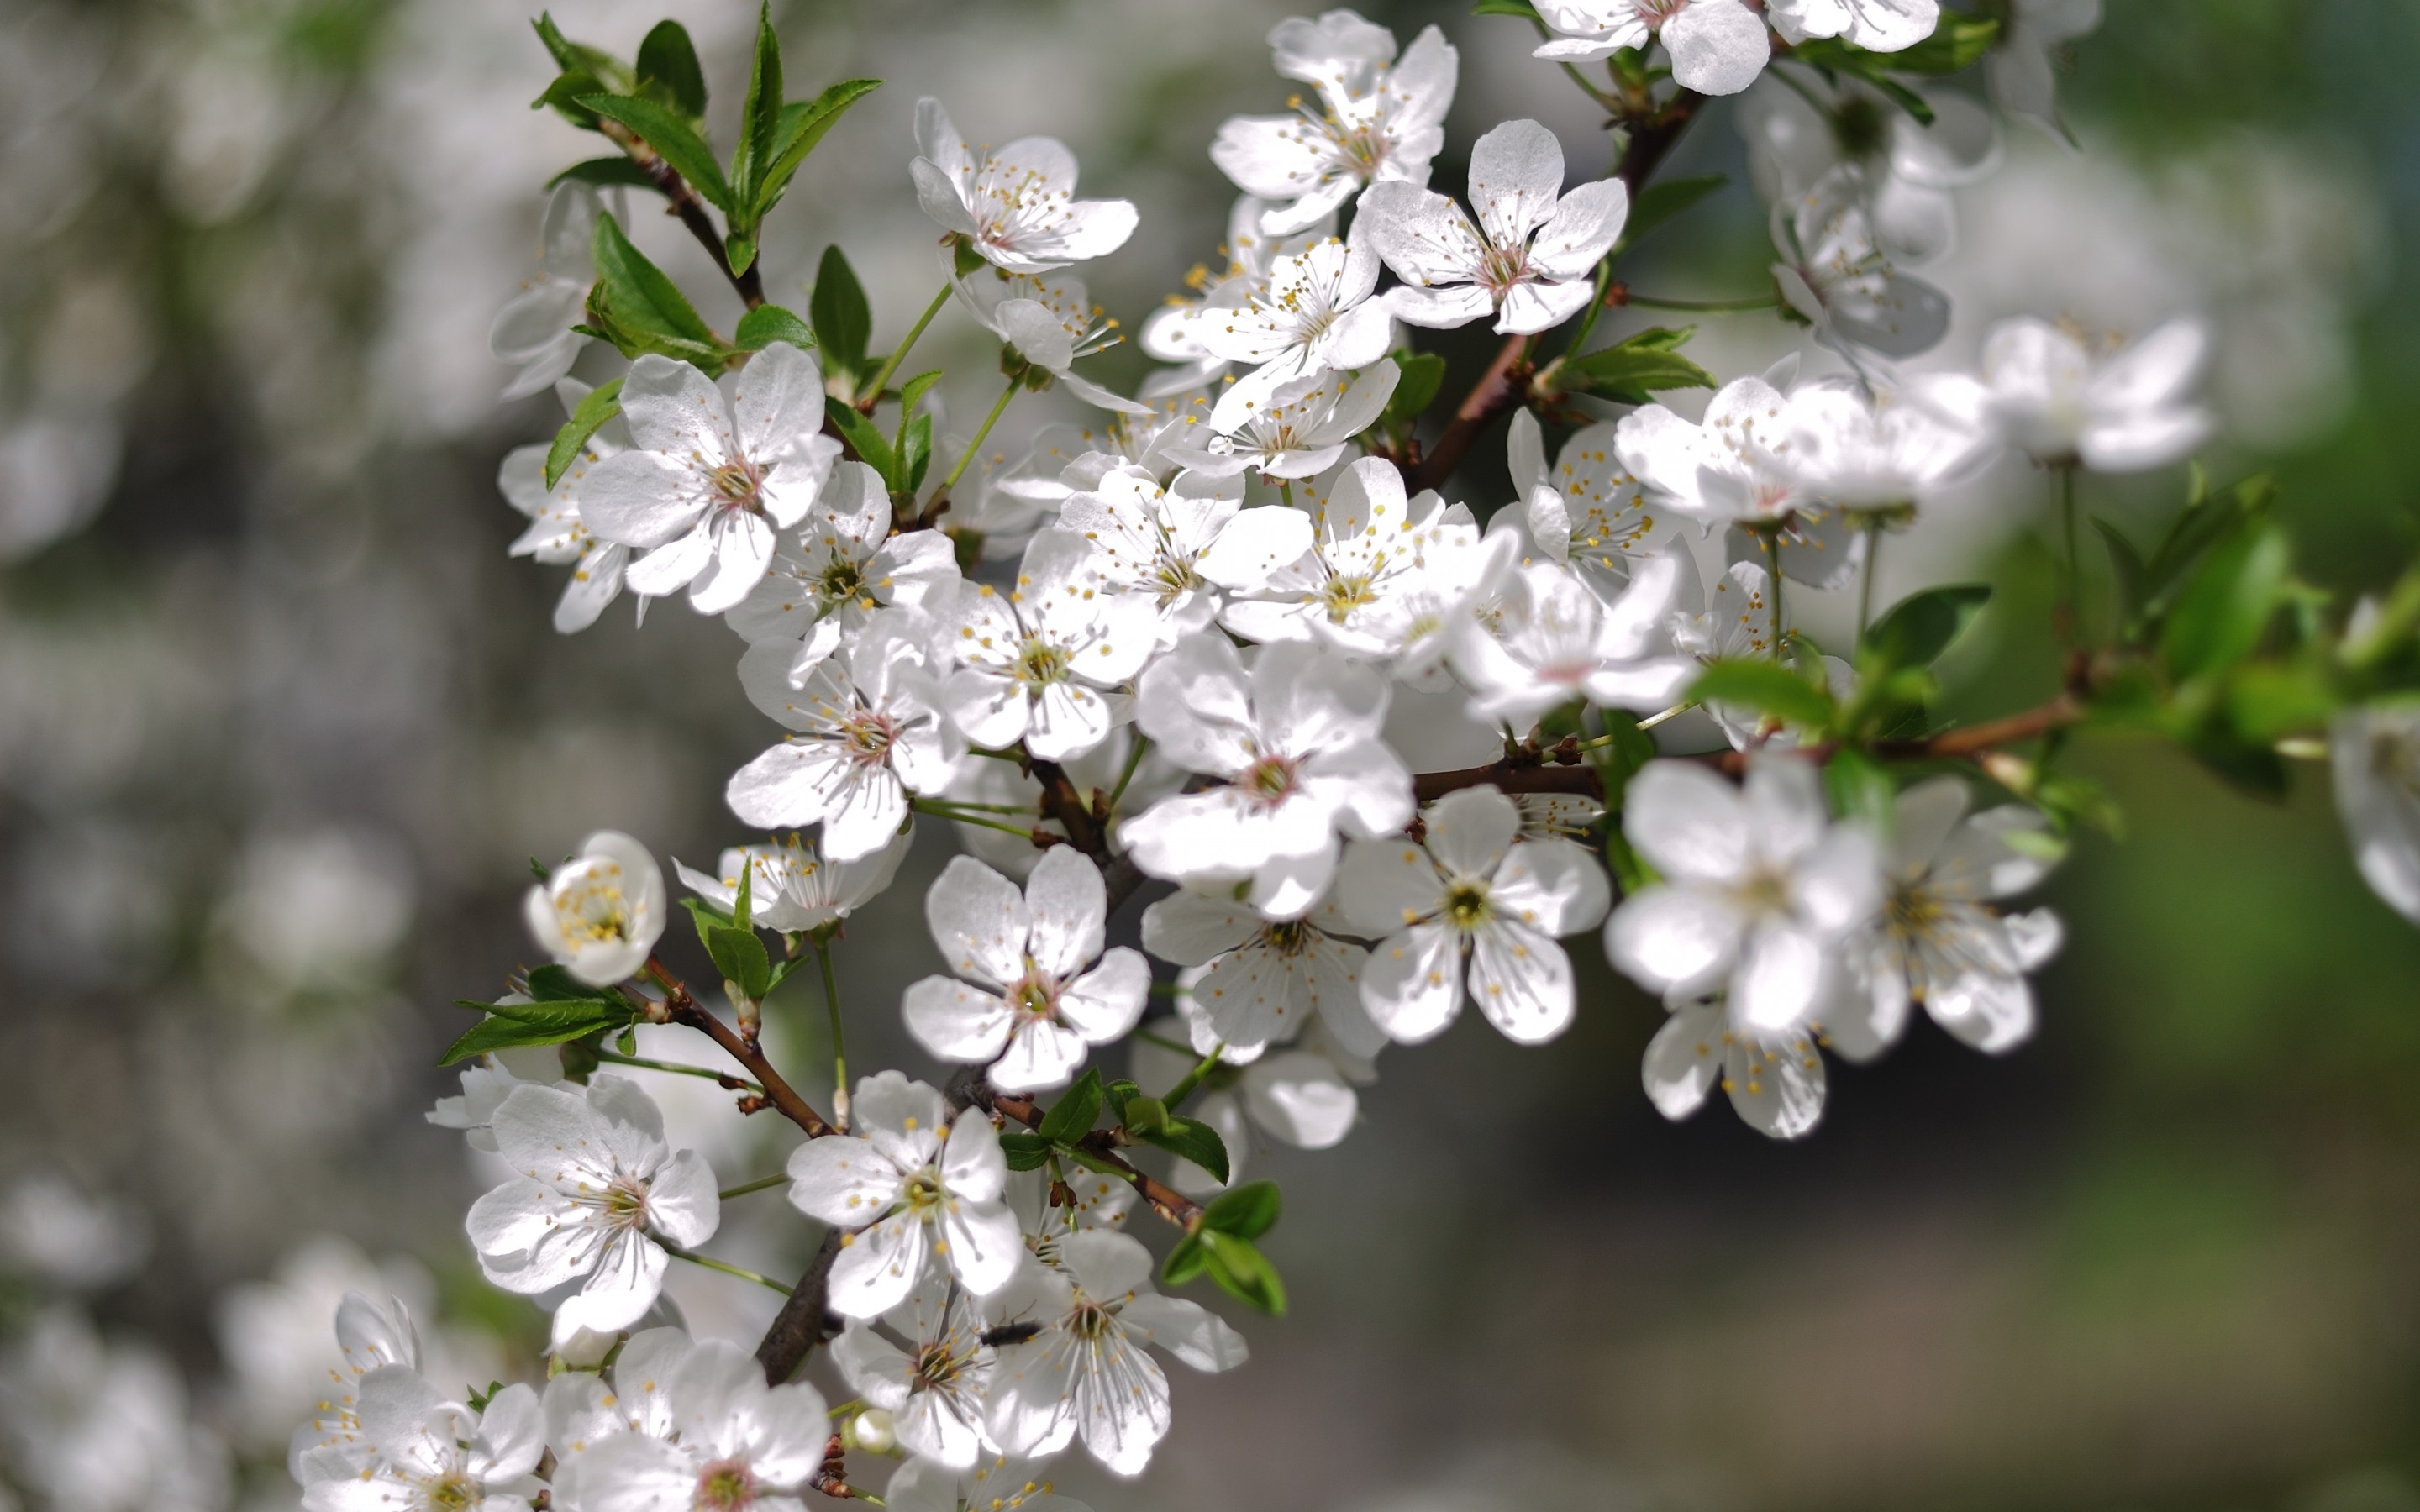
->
1926 317 2212 472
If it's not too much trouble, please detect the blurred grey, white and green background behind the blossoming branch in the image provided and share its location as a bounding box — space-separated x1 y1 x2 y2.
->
0 0 2420 1512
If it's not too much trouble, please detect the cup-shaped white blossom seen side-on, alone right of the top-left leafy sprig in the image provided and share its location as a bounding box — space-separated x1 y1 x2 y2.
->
908 97 1138 273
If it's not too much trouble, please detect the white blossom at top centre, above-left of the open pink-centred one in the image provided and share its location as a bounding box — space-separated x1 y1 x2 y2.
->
1210 10 1462 237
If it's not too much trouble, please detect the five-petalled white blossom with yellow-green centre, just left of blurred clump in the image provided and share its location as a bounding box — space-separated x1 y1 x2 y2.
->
1336 786 1612 1045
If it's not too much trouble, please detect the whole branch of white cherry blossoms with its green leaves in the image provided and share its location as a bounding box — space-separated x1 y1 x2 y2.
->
270 0 2420 1512
